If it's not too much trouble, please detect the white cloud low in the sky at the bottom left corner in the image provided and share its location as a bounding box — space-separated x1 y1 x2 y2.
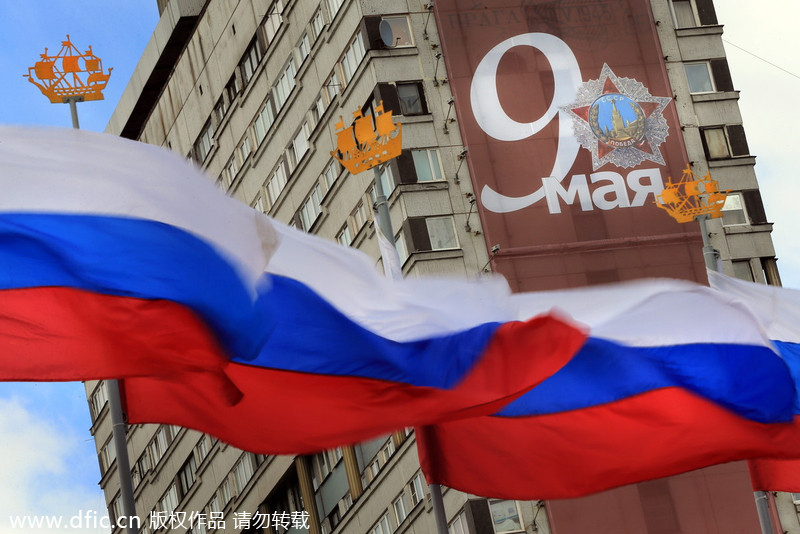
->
0 397 108 534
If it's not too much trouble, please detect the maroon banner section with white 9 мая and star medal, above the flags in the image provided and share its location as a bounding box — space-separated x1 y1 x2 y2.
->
434 0 705 291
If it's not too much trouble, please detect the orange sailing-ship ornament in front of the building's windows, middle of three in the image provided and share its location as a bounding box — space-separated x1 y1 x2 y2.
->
331 102 403 174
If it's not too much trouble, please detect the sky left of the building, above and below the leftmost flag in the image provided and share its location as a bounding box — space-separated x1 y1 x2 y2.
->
0 0 158 534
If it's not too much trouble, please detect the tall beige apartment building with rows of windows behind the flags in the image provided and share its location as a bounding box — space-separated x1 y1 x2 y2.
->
86 0 800 534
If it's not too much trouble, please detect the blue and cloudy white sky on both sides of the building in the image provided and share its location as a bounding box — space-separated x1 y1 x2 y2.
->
0 0 800 534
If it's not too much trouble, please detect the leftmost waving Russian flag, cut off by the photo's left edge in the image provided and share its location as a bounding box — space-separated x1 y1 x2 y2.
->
0 127 276 392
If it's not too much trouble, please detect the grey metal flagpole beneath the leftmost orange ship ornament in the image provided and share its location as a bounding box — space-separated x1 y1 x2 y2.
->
64 102 139 534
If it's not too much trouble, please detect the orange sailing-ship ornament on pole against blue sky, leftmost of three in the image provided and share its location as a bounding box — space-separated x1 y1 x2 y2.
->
23 35 112 104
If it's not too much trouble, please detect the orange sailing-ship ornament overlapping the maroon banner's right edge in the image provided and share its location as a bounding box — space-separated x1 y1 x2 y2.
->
656 165 727 223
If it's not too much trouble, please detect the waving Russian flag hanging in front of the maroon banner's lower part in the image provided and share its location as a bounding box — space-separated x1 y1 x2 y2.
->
417 280 798 499
